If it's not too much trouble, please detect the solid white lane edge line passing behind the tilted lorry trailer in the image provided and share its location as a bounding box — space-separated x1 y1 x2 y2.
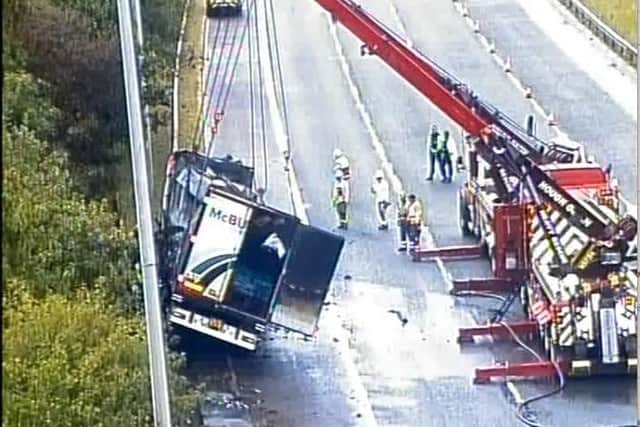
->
260 4 378 427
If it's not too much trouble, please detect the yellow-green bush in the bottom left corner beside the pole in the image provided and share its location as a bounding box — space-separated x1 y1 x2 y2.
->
2 281 197 427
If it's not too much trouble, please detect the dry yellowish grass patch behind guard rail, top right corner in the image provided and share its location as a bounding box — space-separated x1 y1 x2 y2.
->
585 0 638 45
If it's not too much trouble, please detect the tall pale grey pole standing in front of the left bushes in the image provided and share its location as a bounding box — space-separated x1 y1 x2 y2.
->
118 0 171 427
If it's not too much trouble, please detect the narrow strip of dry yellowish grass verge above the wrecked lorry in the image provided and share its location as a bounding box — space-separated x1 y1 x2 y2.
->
178 0 206 148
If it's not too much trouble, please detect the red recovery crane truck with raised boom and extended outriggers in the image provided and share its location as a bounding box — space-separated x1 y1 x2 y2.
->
316 0 637 383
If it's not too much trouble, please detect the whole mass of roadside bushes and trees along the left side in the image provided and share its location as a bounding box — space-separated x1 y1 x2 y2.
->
2 0 200 427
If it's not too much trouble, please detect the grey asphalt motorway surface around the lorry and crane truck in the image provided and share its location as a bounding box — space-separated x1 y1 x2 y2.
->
184 0 636 427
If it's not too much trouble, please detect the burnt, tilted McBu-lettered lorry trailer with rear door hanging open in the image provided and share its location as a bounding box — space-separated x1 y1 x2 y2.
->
160 151 344 351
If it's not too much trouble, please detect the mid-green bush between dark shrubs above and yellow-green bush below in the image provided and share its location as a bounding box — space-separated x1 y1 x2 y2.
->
2 124 136 306
